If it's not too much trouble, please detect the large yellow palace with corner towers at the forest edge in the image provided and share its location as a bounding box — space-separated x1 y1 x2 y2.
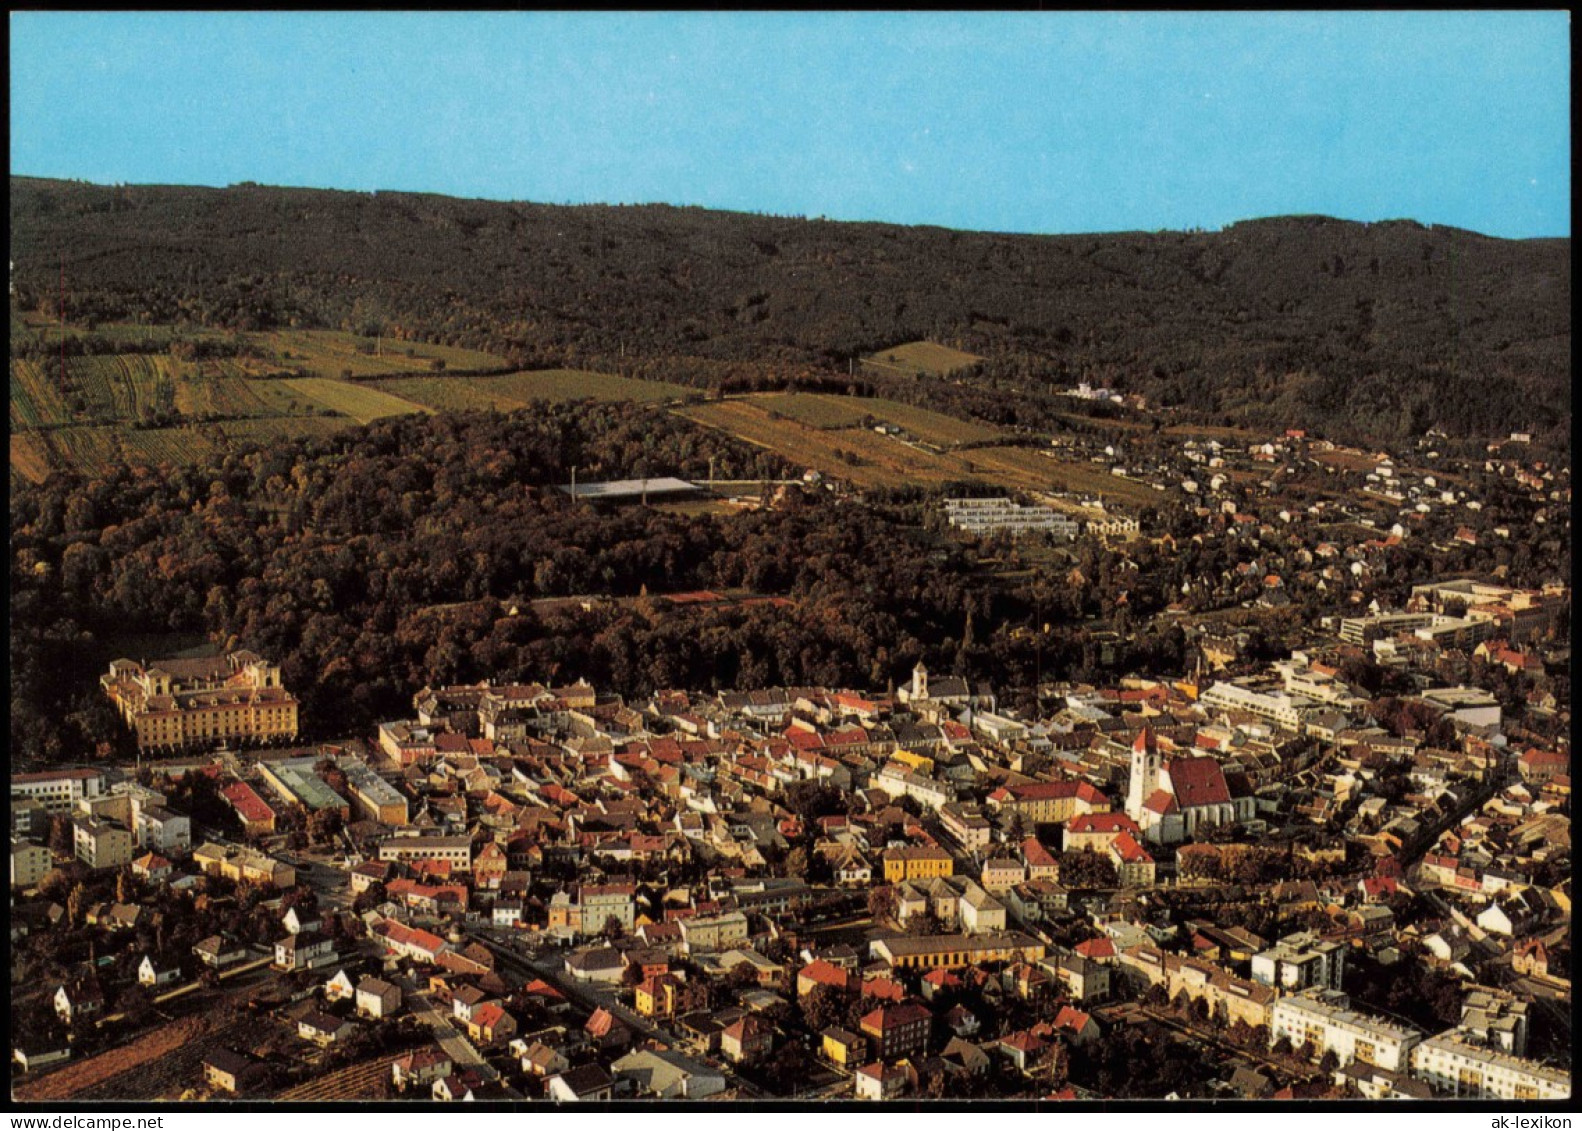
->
100 652 297 751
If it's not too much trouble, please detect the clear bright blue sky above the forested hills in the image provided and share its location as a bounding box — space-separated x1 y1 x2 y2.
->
11 11 1571 237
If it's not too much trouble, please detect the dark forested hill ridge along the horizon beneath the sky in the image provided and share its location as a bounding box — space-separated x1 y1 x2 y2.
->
11 177 1571 438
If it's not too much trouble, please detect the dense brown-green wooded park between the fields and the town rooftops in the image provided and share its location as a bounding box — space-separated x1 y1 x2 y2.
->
9 405 1202 764
